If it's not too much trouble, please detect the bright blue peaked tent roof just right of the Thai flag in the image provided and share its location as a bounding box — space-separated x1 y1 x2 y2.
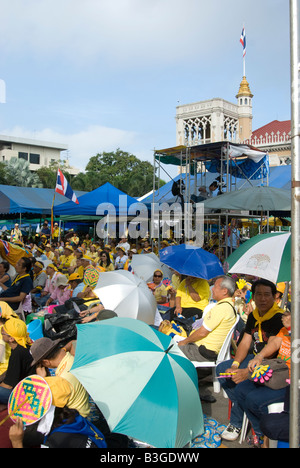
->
53 182 138 216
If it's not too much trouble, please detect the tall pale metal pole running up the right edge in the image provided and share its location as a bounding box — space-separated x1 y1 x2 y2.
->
290 0 300 448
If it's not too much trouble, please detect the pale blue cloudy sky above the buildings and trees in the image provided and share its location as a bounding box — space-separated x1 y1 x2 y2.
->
0 0 290 180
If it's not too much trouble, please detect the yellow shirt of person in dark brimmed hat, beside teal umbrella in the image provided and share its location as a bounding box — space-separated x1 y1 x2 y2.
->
55 353 90 418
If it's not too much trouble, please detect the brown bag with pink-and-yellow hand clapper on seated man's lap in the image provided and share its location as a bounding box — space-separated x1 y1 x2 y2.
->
248 358 289 390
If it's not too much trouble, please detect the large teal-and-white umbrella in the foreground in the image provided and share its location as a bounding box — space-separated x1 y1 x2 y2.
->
71 317 203 448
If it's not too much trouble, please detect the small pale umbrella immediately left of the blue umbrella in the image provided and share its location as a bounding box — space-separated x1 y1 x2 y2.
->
131 252 172 283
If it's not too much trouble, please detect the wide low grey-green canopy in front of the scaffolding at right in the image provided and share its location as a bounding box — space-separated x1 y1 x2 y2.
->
204 187 291 211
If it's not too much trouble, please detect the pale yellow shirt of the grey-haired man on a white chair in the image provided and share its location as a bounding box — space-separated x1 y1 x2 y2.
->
192 297 236 354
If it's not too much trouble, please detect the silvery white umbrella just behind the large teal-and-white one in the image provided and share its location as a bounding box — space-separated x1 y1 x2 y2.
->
94 270 156 325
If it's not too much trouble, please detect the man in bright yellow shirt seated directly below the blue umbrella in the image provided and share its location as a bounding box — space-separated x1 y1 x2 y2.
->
174 276 210 318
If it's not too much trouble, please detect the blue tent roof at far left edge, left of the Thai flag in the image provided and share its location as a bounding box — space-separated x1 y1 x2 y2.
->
0 185 86 215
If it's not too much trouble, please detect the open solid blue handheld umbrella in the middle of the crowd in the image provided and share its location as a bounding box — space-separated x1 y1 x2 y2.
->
159 244 224 281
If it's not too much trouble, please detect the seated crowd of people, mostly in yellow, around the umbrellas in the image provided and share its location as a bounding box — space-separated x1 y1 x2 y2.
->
0 225 291 447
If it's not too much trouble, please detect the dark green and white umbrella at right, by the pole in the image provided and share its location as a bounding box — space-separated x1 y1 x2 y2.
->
226 232 291 283
